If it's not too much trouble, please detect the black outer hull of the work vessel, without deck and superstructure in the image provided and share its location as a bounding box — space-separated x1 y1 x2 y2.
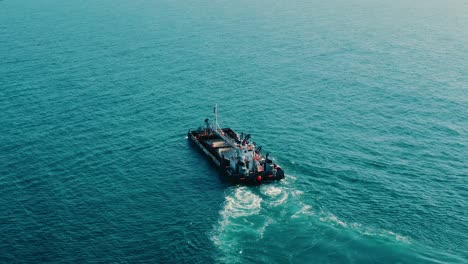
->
187 128 284 184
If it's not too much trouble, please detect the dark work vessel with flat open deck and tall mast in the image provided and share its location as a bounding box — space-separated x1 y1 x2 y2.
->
187 105 284 184
